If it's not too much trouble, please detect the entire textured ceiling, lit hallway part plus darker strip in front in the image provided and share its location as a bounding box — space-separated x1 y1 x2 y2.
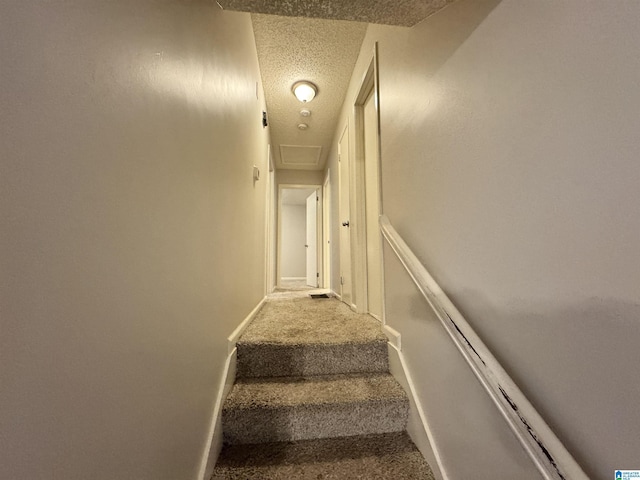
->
218 0 455 170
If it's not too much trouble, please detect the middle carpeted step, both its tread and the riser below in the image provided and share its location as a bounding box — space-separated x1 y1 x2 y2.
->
222 373 409 444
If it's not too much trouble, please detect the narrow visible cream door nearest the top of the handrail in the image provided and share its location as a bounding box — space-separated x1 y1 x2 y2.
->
364 92 382 319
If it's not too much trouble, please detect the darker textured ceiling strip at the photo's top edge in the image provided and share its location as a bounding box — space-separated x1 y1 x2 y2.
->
218 0 454 27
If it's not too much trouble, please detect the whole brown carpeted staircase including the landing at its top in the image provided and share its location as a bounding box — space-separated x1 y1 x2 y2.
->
213 297 433 479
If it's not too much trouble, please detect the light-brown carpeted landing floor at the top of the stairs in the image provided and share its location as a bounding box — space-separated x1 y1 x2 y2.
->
238 298 387 346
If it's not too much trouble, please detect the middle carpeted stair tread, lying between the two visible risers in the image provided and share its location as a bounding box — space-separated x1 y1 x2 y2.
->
223 373 407 410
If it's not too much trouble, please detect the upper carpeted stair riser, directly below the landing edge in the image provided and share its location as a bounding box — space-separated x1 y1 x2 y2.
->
237 342 389 378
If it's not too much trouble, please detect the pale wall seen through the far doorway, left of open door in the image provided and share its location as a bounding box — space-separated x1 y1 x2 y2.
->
280 205 307 278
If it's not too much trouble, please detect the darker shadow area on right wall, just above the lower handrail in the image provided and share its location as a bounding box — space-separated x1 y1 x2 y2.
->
440 291 640 478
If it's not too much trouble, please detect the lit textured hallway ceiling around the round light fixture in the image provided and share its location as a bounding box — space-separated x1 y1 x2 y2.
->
252 14 367 170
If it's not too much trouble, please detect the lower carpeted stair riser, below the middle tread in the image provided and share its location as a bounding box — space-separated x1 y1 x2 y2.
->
222 399 409 444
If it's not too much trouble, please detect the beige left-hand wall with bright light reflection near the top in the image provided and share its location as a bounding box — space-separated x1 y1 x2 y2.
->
0 0 267 480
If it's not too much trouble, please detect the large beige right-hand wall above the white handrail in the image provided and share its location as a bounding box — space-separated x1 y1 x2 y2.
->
332 0 640 478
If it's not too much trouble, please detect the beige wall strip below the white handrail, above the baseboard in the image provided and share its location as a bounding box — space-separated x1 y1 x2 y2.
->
383 246 541 480
